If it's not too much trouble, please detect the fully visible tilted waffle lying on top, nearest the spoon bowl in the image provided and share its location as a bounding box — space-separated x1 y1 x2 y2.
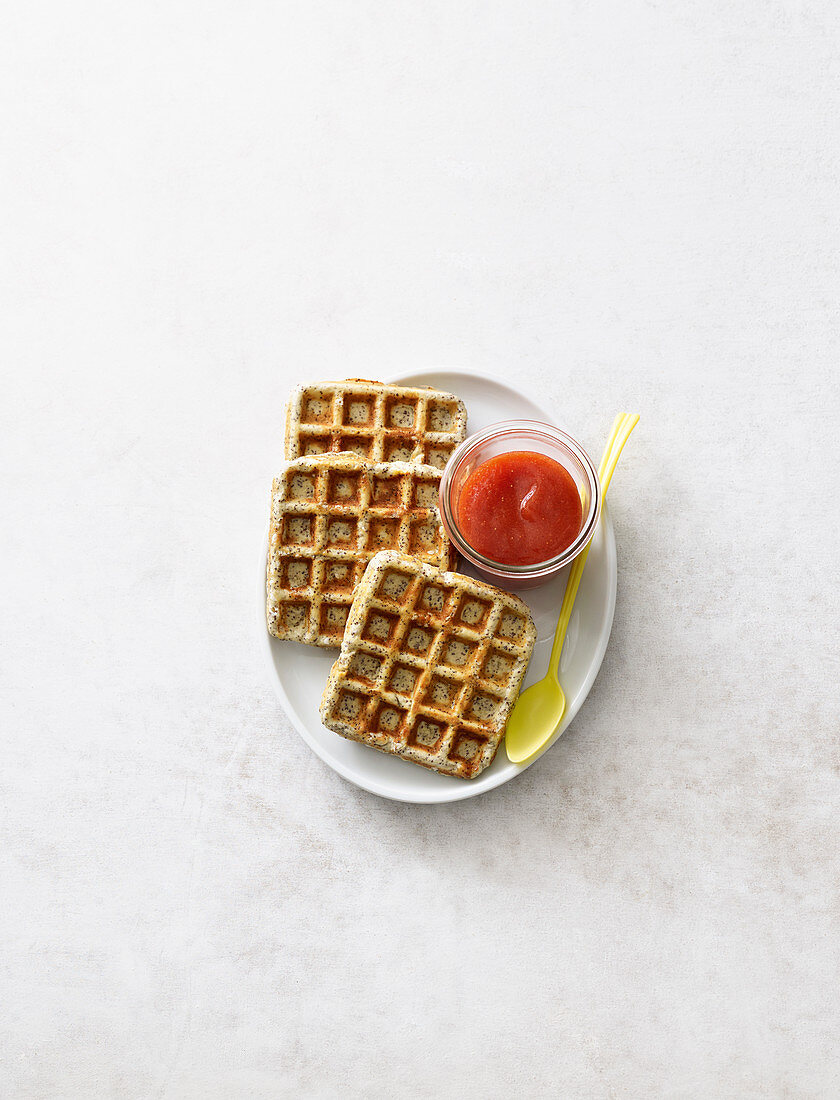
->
321 551 537 779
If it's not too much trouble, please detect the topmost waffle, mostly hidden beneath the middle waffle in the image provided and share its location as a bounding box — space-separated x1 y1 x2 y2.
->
285 378 466 470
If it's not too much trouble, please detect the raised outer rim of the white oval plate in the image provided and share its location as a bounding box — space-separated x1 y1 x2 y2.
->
257 366 618 805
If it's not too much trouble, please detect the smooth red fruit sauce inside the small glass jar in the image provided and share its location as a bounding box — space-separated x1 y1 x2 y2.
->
457 451 583 565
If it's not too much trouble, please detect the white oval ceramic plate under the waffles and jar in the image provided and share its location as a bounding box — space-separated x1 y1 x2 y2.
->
258 370 617 802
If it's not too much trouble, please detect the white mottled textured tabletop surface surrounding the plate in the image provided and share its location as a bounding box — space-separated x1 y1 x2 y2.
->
0 0 840 1100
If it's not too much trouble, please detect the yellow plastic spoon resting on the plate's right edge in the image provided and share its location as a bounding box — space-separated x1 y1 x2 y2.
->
505 413 639 763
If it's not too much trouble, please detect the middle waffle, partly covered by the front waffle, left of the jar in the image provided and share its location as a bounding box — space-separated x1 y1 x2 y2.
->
266 454 454 647
